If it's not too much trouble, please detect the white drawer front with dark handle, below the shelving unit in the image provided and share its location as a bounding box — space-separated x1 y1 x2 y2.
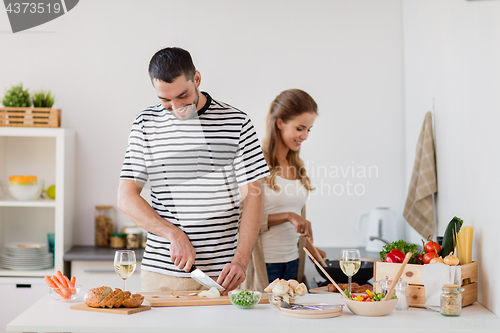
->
0 277 47 333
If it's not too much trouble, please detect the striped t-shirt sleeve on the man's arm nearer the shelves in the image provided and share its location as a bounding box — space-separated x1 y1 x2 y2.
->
120 115 148 183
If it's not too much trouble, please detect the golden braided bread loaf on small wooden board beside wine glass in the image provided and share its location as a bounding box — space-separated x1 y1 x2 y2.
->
83 286 144 308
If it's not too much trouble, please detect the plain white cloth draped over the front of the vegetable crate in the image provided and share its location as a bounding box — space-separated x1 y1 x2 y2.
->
422 263 462 311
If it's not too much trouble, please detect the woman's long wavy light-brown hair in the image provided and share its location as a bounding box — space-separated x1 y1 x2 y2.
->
262 89 318 191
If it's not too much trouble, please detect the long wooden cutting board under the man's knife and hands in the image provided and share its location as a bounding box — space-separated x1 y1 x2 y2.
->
141 290 269 306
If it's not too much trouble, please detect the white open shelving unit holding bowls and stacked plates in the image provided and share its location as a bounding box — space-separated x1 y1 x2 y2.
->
0 127 75 277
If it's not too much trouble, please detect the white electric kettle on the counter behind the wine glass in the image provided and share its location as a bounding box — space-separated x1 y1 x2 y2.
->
358 207 402 252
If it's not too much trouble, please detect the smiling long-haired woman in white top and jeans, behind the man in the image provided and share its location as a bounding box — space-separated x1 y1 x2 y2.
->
260 89 325 282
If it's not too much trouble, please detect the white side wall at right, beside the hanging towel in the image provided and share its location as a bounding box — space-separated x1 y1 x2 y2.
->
403 0 500 315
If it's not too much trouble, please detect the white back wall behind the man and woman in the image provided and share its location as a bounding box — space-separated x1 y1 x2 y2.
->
0 0 404 246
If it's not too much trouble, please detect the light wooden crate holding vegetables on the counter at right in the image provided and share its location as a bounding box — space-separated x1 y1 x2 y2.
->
373 261 478 308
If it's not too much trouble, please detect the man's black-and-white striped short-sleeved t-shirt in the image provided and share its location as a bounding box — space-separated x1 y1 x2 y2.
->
120 93 269 277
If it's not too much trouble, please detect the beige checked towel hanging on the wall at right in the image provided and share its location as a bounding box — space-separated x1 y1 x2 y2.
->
403 111 437 238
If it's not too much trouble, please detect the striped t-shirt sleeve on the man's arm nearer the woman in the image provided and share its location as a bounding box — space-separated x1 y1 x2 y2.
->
234 116 269 186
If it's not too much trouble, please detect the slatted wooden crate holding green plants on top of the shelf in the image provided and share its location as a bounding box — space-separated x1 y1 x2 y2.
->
0 107 61 127
